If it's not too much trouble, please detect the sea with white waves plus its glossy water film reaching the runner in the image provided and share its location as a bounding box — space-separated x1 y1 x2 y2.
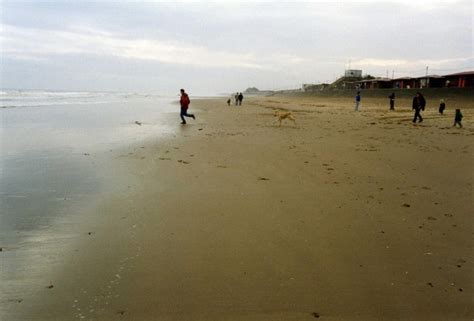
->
0 90 180 319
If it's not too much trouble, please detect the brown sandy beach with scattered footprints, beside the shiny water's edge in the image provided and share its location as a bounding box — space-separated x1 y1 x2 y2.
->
0 91 474 321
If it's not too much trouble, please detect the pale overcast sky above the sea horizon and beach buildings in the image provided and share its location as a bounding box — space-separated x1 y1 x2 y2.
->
0 0 474 95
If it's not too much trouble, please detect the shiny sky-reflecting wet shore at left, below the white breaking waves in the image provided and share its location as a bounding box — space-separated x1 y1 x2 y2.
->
0 100 178 320
